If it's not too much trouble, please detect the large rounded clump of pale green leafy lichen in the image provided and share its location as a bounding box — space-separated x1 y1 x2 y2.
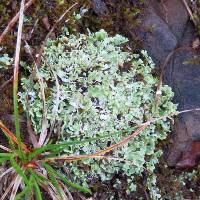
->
20 30 176 196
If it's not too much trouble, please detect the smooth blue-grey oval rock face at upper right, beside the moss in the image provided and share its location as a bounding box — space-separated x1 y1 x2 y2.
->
140 2 178 65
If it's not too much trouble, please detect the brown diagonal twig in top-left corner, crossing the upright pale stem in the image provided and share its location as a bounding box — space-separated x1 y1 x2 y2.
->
0 0 35 44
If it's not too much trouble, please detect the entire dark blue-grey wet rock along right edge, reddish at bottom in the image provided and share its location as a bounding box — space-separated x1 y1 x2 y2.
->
141 0 200 166
